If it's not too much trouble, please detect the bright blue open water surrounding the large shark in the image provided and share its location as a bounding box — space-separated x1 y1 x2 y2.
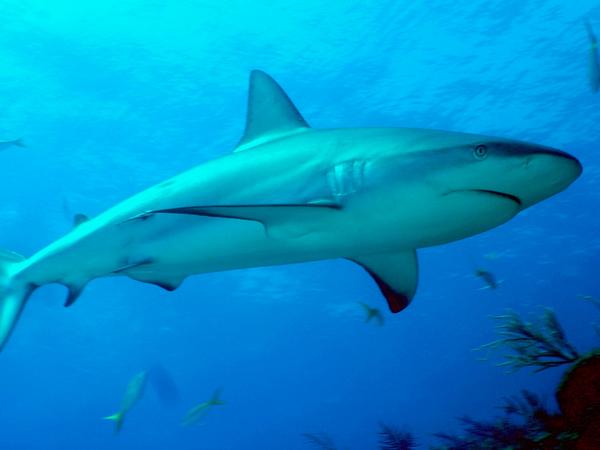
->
0 0 600 450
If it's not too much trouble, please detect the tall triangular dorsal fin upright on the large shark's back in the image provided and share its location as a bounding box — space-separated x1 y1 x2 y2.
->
235 70 309 152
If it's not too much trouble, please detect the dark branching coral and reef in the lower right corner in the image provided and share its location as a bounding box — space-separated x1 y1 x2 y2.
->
304 310 600 450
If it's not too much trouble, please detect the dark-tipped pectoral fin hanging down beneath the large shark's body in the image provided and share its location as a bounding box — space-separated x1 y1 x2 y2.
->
350 250 419 313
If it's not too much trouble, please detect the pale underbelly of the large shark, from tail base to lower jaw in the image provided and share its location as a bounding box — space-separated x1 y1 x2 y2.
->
16 176 518 285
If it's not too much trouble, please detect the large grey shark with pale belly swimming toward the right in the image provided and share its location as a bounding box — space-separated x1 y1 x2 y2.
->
0 70 582 347
